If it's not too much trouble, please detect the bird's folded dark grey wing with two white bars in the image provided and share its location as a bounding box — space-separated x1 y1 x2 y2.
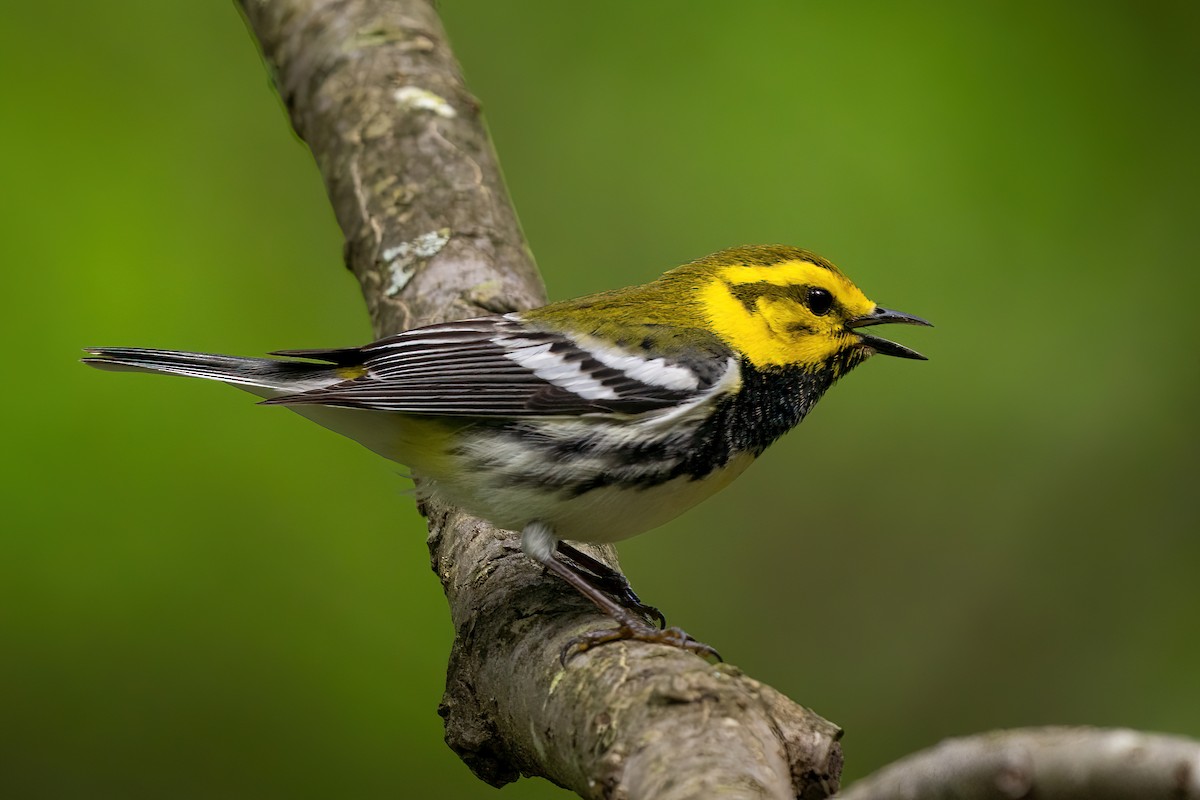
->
265 314 731 416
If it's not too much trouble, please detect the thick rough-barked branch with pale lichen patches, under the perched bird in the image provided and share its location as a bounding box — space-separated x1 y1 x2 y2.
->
241 0 841 800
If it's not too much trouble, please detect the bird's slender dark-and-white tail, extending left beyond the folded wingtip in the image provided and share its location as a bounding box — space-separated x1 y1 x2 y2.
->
83 348 342 396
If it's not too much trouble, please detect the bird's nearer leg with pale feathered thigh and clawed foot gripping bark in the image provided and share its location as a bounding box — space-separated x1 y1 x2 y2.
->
521 522 721 663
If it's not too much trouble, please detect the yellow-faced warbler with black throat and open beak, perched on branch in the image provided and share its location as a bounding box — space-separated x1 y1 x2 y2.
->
83 245 930 662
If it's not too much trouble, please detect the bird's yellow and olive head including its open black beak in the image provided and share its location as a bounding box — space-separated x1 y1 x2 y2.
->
685 246 930 373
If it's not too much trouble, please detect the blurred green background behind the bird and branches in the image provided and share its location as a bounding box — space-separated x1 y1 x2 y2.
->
0 0 1200 798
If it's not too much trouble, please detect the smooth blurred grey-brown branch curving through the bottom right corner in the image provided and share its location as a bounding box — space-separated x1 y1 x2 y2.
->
838 728 1200 800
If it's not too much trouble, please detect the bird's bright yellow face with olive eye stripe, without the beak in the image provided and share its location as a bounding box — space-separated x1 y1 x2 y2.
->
701 258 876 368
